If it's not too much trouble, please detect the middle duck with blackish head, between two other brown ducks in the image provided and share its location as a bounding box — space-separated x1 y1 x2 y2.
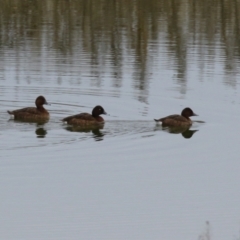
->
62 105 107 126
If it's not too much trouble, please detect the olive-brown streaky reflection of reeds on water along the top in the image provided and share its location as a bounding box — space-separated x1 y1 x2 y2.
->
0 0 240 89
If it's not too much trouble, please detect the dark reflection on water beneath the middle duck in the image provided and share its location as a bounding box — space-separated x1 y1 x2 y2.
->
65 125 105 141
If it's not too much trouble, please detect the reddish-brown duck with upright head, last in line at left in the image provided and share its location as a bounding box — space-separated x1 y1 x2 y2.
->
7 96 50 121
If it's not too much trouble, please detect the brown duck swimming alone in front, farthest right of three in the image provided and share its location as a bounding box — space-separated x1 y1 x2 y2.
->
154 107 198 127
